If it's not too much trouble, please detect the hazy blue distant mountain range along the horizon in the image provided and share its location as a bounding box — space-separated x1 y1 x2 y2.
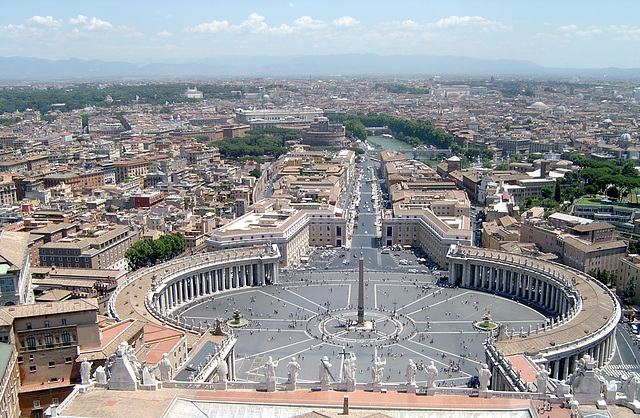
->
0 54 640 82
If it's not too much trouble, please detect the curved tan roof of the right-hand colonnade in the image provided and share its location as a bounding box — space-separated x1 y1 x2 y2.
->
453 246 620 355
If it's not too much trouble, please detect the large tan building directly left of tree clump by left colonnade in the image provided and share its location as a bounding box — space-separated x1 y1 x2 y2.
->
38 226 139 269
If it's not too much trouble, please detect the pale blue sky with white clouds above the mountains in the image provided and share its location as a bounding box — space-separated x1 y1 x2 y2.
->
0 0 640 68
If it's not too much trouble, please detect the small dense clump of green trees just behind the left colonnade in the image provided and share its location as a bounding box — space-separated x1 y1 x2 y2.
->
124 233 185 271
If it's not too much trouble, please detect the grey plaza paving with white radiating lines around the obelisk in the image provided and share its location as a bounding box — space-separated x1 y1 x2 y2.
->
183 270 544 386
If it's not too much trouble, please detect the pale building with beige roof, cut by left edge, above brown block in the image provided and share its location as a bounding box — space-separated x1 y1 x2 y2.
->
0 230 34 306
